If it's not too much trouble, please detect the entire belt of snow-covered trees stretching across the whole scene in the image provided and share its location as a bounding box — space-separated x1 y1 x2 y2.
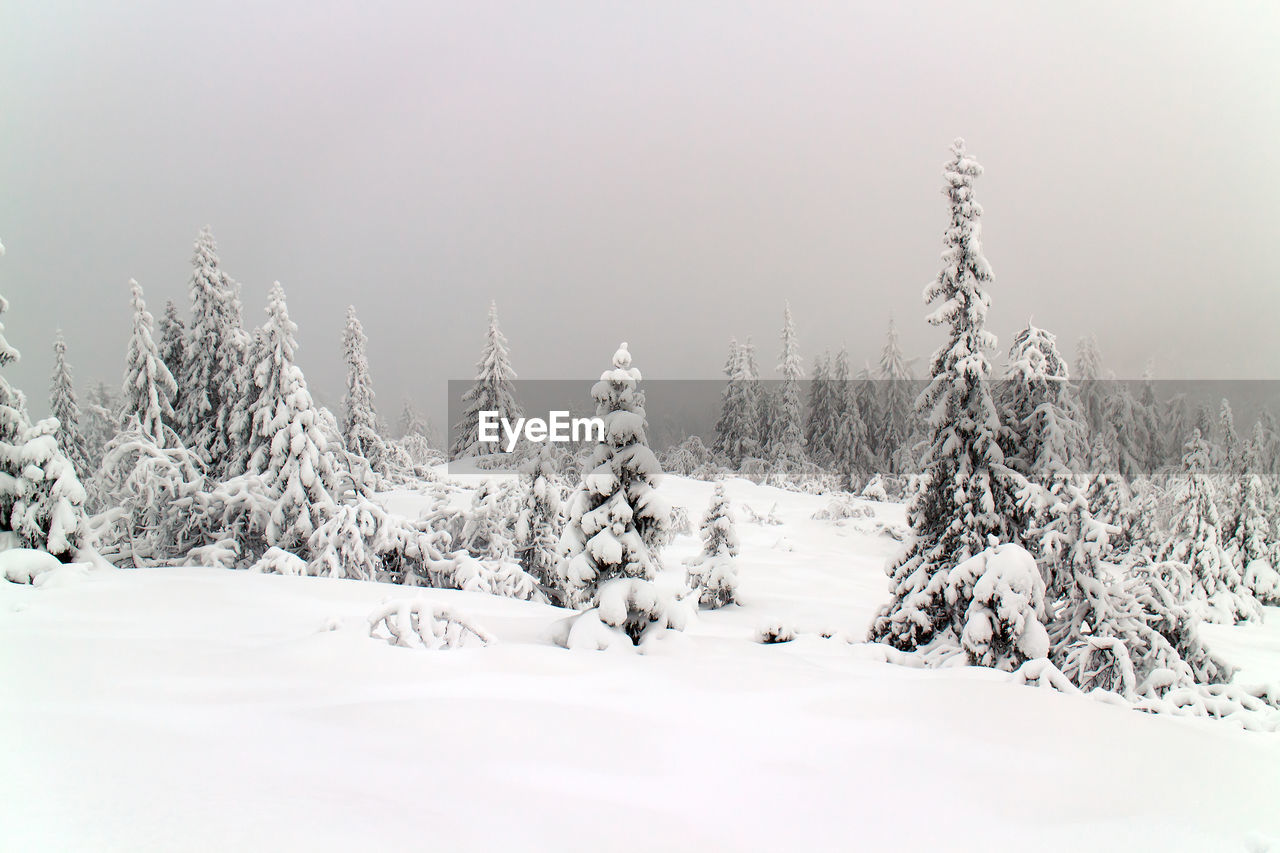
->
0 141 1280 686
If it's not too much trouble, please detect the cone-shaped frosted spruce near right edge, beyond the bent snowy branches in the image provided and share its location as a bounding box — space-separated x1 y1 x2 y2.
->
1160 429 1262 622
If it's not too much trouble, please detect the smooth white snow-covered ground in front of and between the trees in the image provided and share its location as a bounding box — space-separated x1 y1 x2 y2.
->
0 478 1280 852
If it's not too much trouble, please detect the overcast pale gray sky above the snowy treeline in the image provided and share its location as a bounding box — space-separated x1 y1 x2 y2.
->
0 0 1280 419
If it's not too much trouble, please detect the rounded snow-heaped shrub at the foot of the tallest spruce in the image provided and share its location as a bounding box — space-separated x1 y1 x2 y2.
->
946 544 1050 671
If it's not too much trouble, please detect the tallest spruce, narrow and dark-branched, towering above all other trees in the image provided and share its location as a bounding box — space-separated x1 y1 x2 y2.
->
870 140 1020 651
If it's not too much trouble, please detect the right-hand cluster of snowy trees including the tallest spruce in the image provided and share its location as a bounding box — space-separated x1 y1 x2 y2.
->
870 141 1277 701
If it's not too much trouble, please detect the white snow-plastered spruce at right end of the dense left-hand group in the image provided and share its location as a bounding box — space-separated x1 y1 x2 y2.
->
248 282 338 551
